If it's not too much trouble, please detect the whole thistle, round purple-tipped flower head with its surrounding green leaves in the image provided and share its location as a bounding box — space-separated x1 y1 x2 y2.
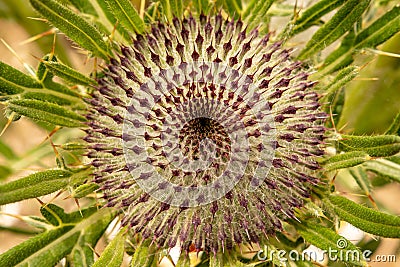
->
0 0 400 267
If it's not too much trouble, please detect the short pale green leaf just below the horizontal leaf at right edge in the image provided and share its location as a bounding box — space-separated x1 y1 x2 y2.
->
323 151 370 171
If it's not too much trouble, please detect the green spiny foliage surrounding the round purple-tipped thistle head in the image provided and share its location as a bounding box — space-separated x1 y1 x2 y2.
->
0 0 400 267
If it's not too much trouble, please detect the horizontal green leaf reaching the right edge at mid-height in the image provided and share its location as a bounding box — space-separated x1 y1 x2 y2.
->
339 135 400 157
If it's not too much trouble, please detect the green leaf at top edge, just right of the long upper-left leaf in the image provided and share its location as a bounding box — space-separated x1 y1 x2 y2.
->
105 0 145 34
